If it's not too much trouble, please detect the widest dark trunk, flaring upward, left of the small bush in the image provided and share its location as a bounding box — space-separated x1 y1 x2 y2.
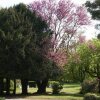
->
36 79 48 94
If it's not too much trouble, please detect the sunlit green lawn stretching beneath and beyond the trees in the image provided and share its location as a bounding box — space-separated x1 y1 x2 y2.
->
5 84 83 100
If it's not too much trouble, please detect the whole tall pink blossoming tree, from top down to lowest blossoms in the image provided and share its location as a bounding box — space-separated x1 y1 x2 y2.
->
28 0 89 94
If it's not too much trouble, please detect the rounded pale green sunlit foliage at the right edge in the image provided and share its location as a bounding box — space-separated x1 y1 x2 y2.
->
74 40 100 77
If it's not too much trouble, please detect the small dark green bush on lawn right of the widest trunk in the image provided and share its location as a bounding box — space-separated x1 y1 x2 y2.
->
52 82 63 94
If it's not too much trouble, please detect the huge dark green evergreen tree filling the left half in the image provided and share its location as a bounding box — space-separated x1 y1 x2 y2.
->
0 4 51 94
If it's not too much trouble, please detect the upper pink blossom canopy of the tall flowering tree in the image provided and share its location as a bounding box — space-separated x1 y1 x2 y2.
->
28 0 89 47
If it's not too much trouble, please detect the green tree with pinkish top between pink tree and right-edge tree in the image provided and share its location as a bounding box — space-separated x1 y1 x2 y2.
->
63 52 86 82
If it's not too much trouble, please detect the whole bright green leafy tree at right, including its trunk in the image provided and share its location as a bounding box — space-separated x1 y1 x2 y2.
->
68 40 100 92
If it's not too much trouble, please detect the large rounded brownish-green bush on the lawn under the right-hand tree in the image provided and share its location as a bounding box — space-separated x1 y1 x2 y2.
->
80 80 98 94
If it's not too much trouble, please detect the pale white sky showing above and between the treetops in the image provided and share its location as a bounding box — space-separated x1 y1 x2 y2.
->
0 0 100 39
